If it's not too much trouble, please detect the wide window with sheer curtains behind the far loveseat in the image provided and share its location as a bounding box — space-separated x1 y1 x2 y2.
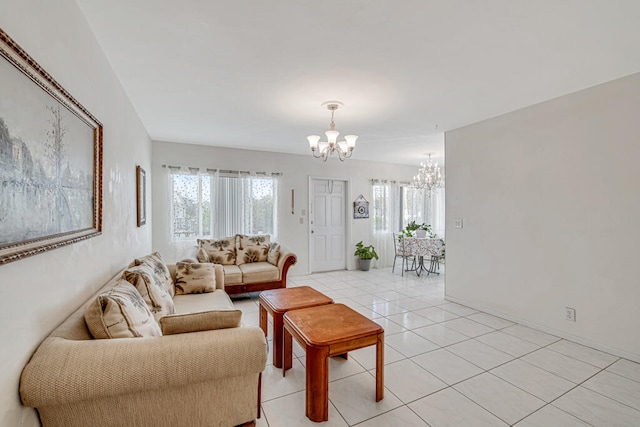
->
169 171 278 241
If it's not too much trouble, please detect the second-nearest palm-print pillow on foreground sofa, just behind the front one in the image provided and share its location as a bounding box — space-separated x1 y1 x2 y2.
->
122 265 176 319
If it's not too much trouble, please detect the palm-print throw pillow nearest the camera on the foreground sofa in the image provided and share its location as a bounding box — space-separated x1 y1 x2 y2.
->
84 279 162 339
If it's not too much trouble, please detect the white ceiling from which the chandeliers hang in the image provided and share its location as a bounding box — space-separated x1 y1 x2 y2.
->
76 0 640 165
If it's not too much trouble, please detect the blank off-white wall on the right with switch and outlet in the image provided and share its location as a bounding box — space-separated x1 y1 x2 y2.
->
445 74 640 361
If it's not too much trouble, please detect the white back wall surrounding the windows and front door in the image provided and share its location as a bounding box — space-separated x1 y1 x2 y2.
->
152 140 417 276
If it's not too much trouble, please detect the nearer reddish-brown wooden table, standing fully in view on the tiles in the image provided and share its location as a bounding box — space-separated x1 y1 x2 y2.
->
282 304 384 422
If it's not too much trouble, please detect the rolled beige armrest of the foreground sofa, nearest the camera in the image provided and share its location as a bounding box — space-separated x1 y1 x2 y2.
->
20 327 267 408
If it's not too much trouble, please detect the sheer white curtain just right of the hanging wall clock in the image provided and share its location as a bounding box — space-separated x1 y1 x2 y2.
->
369 179 400 267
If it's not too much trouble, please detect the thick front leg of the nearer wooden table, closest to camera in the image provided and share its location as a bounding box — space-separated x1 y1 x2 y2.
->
306 347 329 422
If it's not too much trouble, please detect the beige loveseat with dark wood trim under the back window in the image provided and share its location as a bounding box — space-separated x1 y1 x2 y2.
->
196 234 298 294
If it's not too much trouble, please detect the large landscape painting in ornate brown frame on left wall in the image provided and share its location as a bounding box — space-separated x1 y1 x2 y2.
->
0 29 102 264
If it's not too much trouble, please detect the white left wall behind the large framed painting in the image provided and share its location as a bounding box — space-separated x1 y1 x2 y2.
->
0 0 151 426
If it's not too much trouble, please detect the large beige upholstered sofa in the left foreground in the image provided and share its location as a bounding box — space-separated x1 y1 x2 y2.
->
20 254 267 427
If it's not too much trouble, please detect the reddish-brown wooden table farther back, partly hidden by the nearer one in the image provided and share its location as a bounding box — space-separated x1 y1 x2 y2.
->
259 286 333 368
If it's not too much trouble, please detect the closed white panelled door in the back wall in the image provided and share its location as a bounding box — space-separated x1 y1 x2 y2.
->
309 178 347 273
